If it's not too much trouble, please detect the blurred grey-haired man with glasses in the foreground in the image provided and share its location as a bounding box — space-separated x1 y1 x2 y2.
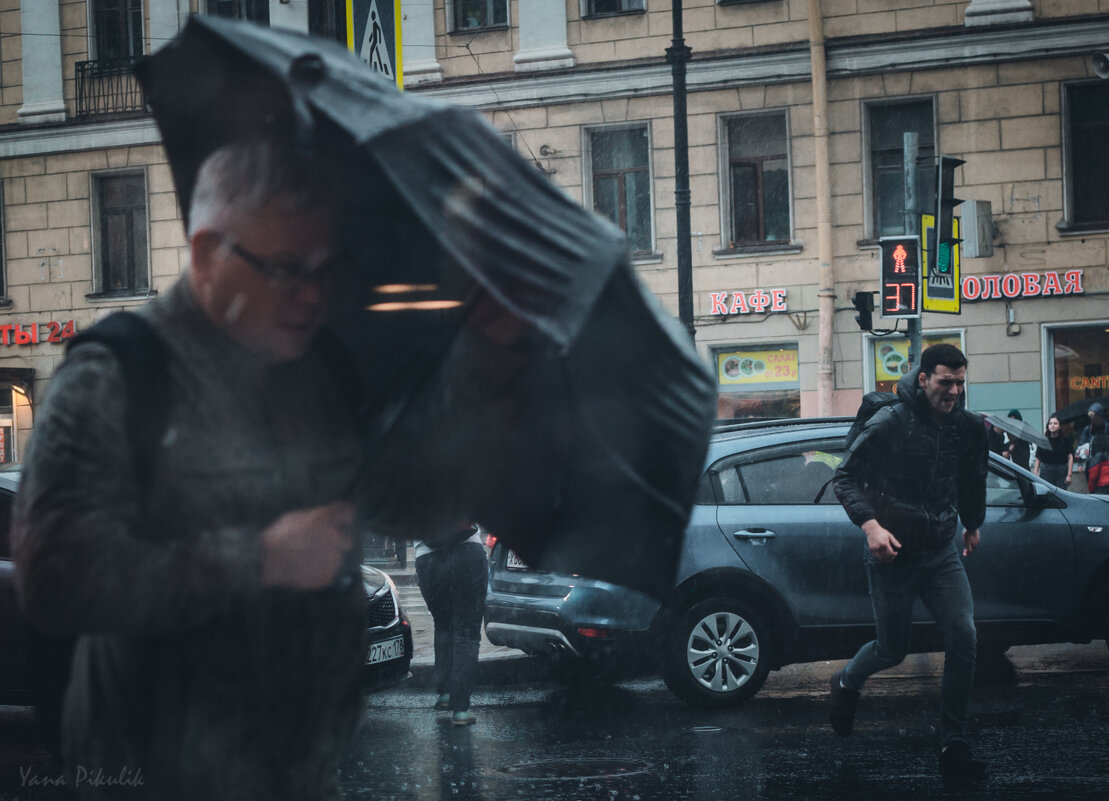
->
14 141 366 801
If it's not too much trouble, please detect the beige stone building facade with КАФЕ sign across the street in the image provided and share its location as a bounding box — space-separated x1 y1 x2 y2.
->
0 0 1109 460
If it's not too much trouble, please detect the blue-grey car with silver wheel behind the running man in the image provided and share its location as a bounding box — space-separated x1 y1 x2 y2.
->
486 418 1109 707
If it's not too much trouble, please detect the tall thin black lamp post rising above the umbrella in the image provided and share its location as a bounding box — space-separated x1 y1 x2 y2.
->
667 0 696 339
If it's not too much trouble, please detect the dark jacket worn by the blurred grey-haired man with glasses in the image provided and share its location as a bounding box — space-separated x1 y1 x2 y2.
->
13 277 366 801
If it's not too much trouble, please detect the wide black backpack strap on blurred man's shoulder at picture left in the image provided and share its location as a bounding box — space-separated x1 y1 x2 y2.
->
65 312 171 507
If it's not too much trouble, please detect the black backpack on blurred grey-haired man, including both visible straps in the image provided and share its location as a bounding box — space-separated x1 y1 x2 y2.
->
24 312 362 756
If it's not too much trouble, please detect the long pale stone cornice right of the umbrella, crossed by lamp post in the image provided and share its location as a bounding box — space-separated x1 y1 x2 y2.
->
415 18 1109 109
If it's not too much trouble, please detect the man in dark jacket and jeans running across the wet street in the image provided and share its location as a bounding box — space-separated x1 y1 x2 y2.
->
830 344 987 778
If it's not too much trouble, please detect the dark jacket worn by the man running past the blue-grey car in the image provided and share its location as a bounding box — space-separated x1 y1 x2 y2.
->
834 369 988 555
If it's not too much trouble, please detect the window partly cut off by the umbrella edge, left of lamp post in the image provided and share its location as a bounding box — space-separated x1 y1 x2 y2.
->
588 124 652 254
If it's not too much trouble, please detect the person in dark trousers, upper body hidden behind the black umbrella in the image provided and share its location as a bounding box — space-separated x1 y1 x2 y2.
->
416 527 489 726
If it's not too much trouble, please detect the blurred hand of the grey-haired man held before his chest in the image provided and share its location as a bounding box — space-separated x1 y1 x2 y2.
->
262 503 354 590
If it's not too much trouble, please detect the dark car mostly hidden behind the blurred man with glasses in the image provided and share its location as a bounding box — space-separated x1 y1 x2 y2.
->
0 469 413 704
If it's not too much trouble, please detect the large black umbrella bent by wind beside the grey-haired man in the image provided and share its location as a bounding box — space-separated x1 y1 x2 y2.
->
136 17 714 596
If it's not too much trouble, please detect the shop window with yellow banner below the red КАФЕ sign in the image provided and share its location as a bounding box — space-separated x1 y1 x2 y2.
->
715 345 801 420
